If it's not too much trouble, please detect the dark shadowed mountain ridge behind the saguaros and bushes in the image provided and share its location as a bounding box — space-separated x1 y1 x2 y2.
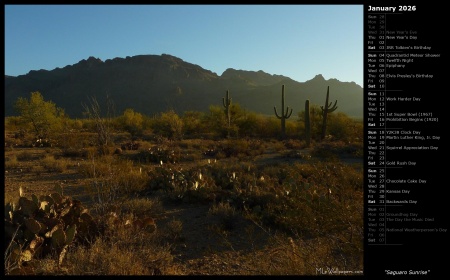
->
5 54 363 118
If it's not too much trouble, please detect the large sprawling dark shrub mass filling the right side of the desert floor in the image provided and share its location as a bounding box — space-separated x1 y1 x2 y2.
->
217 159 363 250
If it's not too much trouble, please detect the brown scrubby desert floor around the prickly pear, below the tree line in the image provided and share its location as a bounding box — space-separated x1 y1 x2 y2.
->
5 133 363 275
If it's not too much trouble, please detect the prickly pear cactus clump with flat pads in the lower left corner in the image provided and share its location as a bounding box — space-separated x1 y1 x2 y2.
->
4 190 98 267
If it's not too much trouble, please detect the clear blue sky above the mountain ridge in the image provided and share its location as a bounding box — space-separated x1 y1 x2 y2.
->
4 5 363 86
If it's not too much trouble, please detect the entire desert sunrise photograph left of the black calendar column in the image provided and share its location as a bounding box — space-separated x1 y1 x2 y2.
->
4 4 364 276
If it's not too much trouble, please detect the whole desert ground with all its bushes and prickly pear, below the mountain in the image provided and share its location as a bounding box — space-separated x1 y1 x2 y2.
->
4 100 364 275
